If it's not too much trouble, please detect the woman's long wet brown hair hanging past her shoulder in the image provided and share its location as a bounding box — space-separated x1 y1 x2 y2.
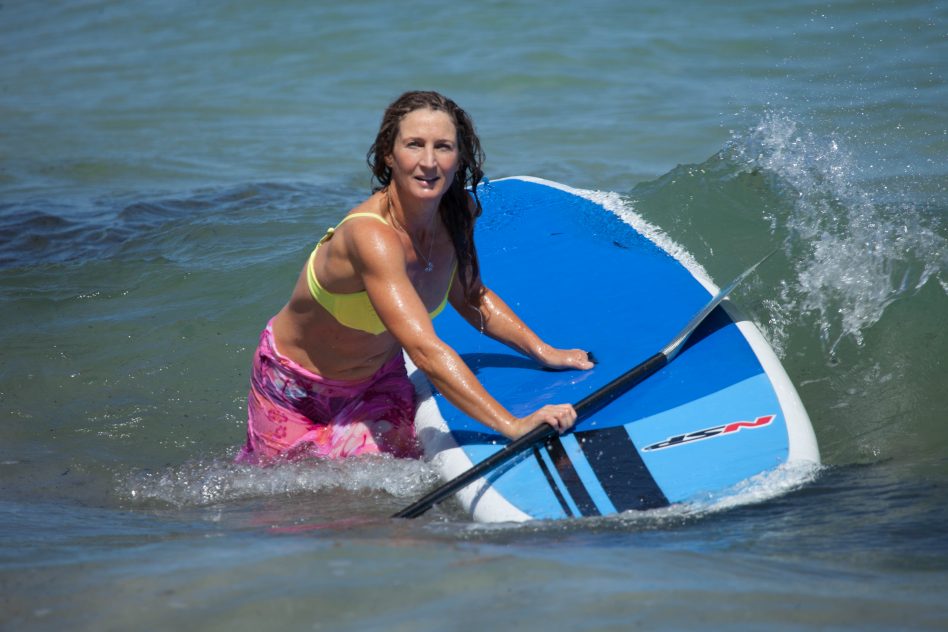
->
366 91 484 307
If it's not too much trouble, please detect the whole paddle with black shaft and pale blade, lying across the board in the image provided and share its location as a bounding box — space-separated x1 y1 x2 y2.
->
392 250 776 518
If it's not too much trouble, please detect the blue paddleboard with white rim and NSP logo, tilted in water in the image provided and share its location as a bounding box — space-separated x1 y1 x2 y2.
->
409 177 819 522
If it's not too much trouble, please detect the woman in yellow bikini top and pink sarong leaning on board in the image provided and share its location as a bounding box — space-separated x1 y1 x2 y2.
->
238 92 592 462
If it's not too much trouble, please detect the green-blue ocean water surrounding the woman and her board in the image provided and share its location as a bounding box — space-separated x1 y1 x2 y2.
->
0 0 948 631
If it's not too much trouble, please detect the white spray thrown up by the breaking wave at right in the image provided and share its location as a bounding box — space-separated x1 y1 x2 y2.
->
723 112 948 356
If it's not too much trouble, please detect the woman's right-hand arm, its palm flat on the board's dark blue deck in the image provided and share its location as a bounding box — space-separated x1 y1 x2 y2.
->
449 276 593 370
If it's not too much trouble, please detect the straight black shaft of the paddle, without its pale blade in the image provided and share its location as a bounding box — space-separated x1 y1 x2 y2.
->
392 352 668 518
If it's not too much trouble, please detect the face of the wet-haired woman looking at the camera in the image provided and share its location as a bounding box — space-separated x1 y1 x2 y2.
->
385 109 459 201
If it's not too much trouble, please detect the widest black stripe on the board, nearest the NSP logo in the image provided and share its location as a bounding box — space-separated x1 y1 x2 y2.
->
576 426 669 511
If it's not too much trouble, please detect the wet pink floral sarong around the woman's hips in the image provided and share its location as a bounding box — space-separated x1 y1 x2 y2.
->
236 322 421 463
